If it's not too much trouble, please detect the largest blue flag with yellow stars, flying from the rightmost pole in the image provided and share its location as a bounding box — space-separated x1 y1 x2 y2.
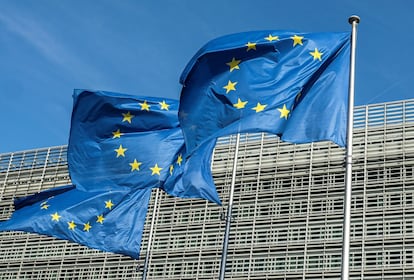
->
179 31 350 154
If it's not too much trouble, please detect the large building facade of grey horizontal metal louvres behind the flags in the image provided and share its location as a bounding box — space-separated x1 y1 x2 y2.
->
0 97 414 280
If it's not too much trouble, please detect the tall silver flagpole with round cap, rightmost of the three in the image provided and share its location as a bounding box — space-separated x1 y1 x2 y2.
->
341 15 360 280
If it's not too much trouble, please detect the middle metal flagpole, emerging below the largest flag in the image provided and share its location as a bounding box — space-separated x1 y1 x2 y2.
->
219 133 240 280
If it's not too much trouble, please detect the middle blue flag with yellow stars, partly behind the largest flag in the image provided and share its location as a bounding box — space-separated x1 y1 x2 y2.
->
68 90 221 204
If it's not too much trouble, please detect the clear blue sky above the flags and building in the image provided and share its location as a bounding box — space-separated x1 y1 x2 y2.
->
0 0 414 153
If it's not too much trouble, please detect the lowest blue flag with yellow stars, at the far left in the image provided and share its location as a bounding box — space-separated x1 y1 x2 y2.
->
0 186 151 259
